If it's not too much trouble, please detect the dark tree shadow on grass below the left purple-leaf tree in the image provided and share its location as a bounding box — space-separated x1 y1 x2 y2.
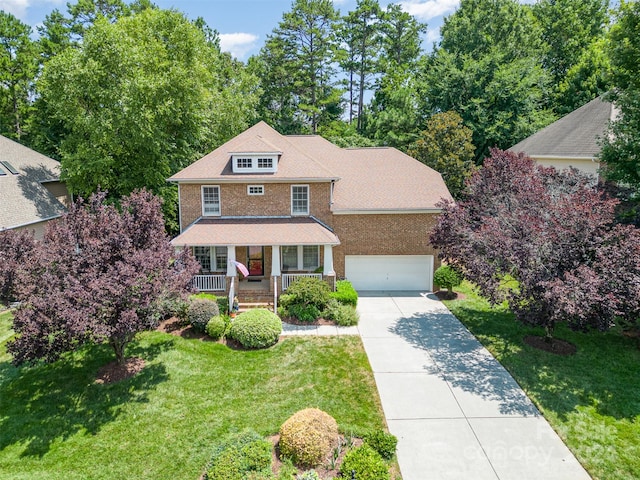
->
0 340 173 457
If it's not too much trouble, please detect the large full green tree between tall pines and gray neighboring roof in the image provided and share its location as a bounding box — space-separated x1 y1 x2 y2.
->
421 0 554 162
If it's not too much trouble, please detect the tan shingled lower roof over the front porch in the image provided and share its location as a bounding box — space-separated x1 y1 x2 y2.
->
171 217 340 246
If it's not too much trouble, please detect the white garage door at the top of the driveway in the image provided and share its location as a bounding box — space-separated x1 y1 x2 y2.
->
345 255 433 291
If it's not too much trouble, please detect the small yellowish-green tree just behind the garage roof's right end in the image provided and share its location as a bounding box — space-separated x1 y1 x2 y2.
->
407 112 475 199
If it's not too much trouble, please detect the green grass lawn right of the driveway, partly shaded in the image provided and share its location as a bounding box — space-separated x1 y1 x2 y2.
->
445 282 640 479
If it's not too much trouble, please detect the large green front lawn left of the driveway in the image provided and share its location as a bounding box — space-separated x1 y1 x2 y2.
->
0 314 384 480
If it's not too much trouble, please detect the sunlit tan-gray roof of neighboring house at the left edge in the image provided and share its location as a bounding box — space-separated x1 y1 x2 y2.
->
0 136 65 230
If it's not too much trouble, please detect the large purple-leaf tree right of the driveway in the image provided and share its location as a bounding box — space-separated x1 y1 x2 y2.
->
431 149 640 337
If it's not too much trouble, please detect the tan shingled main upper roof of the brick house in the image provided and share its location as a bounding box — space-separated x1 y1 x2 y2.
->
169 122 451 213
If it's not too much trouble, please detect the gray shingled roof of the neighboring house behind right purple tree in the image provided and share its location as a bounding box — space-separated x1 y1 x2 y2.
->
509 97 616 158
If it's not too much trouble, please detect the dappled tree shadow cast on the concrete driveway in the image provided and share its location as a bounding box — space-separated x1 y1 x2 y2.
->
389 311 539 416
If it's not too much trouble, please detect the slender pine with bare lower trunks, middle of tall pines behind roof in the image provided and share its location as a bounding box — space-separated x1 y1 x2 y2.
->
337 0 382 133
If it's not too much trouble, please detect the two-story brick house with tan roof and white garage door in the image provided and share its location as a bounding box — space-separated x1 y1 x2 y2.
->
169 122 451 295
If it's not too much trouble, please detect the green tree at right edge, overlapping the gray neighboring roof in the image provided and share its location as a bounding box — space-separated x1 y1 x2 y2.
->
600 1 640 196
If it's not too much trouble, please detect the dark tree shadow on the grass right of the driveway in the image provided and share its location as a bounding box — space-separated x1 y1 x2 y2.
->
450 307 640 421
